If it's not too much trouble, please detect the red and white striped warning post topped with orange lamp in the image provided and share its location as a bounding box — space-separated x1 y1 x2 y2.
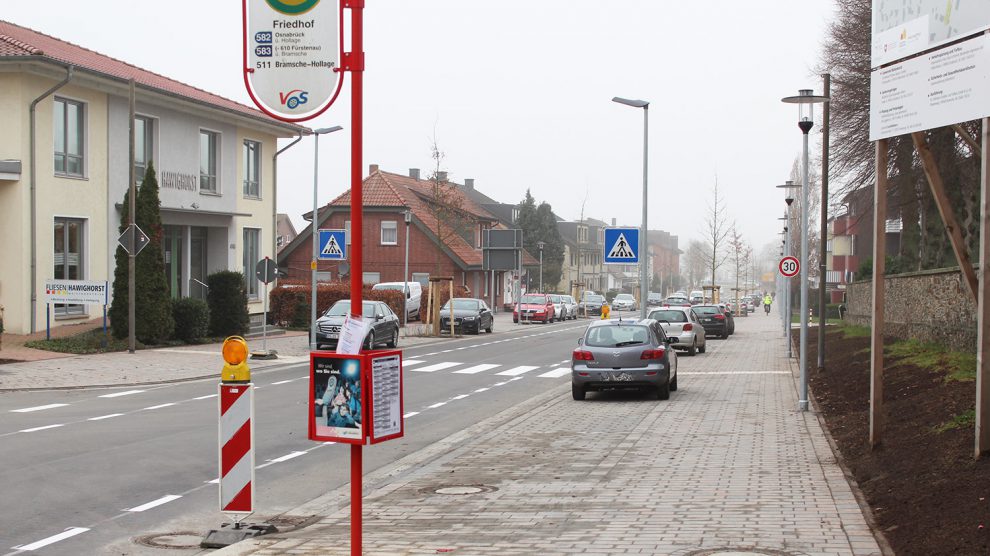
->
219 336 254 527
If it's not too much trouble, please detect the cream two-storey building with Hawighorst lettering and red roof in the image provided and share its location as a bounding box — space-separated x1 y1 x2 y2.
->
0 21 307 333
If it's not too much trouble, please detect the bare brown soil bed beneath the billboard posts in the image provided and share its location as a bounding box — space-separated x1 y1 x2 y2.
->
808 330 990 556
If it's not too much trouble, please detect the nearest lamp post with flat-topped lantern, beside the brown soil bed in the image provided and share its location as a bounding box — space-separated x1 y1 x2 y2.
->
781 89 828 411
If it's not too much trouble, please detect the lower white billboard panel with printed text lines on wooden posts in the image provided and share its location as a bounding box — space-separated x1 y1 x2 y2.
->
870 35 990 141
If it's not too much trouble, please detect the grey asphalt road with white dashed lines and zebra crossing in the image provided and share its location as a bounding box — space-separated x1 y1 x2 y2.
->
0 312 640 555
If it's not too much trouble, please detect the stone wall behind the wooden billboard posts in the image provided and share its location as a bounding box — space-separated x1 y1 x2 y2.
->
846 268 976 351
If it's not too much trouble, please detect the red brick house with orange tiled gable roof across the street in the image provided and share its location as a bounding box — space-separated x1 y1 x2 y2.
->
278 164 538 307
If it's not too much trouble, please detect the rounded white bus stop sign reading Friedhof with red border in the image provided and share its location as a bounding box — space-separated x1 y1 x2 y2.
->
244 0 341 121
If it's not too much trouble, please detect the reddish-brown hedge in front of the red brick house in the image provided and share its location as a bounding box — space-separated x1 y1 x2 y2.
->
268 280 405 328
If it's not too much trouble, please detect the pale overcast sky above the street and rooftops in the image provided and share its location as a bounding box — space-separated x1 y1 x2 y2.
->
0 0 836 256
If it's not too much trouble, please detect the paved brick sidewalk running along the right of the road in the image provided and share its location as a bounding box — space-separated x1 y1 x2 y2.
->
216 315 881 556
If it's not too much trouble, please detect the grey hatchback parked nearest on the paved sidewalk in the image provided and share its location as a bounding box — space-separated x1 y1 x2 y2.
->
571 319 677 400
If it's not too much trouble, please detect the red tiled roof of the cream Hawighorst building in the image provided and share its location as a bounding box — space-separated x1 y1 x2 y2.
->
0 20 306 132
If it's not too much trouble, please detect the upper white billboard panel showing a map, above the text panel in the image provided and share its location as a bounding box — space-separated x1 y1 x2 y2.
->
871 0 990 67
